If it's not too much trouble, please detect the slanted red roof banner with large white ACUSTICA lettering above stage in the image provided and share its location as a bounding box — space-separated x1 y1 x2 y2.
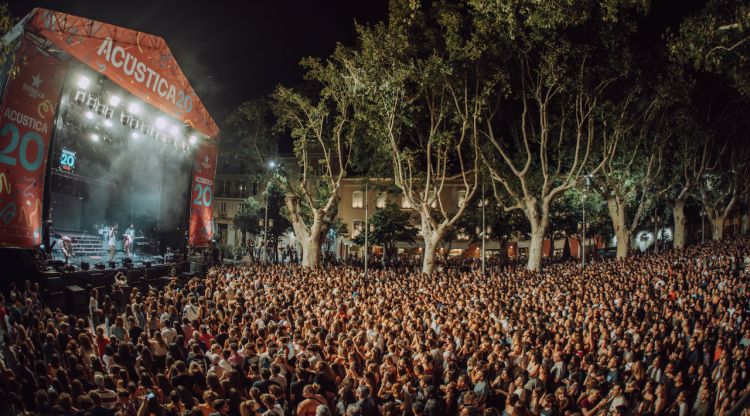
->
27 9 219 139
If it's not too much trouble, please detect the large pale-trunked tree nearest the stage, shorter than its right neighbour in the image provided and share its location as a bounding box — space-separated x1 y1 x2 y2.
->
272 45 360 269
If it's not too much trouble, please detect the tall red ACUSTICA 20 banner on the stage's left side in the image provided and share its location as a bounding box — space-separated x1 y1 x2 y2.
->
0 37 67 247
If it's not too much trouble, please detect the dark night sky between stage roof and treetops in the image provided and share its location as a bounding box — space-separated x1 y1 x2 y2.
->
9 0 388 122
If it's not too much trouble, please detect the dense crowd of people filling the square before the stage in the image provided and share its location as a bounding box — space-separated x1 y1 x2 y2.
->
0 238 750 416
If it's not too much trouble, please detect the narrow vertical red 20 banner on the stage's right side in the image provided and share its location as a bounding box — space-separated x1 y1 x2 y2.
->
188 142 217 246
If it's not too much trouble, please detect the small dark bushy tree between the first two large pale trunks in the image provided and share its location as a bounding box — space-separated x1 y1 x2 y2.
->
354 202 417 264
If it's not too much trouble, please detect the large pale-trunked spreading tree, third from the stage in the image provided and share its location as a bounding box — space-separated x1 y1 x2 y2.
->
469 0 641 270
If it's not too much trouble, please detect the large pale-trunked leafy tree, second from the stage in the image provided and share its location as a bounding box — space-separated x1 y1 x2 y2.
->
356 2 488 274
